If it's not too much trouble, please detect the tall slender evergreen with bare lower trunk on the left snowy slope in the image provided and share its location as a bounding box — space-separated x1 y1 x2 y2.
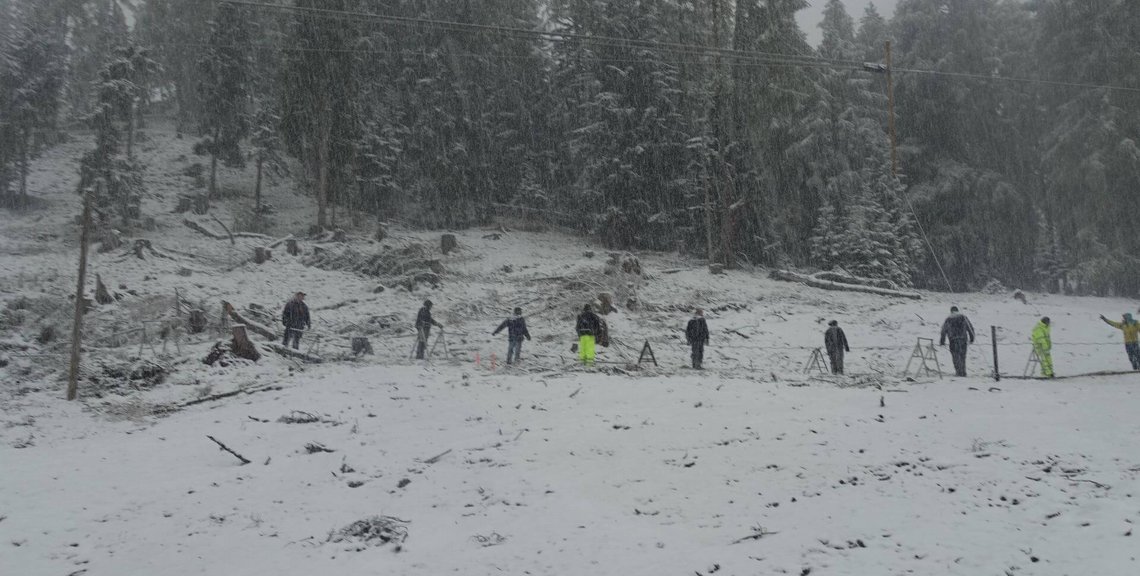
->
195 3 250 198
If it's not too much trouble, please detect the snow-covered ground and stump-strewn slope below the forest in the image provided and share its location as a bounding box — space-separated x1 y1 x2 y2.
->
0 123 1140 575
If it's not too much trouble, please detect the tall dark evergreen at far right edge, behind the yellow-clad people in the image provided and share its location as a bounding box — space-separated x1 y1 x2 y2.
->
1036 0 1140 294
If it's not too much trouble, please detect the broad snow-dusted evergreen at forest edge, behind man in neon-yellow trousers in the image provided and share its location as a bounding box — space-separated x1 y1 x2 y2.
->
555 0 694 248
